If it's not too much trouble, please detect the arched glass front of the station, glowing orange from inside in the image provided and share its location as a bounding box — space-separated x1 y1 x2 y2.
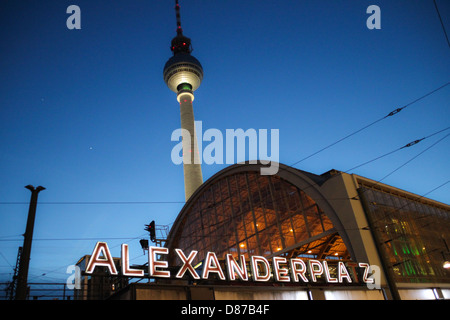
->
168 166 350 265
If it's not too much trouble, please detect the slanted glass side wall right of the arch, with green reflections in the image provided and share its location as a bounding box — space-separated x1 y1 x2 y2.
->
361 185 450 283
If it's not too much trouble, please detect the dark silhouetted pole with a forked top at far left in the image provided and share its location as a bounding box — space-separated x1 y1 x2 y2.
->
16 185 45 300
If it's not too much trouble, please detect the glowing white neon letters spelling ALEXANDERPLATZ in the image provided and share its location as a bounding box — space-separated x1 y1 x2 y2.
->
85 242 378 287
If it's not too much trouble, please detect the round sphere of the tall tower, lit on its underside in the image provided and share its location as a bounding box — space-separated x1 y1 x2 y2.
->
164 52 203 93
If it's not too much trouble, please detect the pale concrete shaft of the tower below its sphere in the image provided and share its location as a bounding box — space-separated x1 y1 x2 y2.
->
178 93 203 201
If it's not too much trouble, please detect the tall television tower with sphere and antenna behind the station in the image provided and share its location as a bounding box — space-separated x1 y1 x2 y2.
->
164 0 203 201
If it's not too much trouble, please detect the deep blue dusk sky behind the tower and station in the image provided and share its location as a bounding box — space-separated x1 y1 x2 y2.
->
0 0 450 288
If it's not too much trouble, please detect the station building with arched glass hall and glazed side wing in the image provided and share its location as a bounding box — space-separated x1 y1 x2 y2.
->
103 164 450 300
